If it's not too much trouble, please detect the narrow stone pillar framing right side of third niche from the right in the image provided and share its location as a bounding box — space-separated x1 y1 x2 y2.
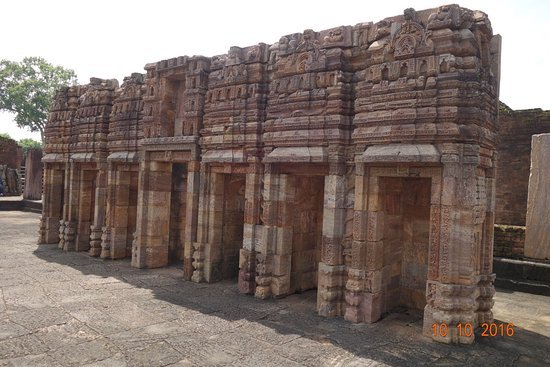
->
239 164 263 294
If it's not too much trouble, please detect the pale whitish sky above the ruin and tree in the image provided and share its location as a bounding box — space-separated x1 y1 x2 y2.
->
0 0 550 139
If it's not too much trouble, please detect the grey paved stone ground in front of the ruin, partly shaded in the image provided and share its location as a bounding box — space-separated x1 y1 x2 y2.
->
0 212 550 367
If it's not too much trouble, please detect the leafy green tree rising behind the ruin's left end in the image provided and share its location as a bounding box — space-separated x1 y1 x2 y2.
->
0 57 76 141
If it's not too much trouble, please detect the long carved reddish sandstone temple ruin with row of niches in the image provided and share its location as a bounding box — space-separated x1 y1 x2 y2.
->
40 5 500 343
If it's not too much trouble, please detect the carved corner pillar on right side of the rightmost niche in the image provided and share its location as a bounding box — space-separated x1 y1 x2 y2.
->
423 144 485 344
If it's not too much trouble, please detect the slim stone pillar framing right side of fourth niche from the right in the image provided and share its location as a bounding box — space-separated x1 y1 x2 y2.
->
183 161 201 280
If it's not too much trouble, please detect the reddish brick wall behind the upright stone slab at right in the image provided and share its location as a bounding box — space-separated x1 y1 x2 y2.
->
495 104 550 226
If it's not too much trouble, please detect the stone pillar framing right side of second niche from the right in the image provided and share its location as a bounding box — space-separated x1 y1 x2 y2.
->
317 163 346 316
